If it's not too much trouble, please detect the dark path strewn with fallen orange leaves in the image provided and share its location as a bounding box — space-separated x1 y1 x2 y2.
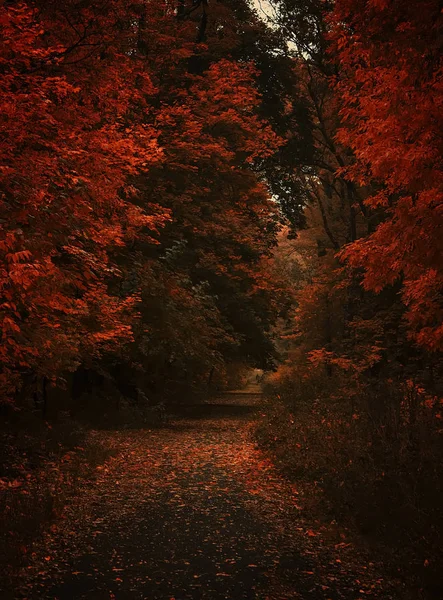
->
5 386 408 600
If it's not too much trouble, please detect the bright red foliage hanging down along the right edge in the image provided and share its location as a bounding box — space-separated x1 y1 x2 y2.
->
331 0 443 350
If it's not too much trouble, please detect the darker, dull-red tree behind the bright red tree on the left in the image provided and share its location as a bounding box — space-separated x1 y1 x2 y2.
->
125 51 279 396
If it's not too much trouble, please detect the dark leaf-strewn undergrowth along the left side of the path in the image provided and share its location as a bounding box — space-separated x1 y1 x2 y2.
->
0 413 116 587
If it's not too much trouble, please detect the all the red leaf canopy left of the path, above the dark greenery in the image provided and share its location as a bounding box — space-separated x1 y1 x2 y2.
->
0 0 280 396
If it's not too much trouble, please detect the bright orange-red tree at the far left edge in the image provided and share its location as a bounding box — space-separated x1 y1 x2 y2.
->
0 1 173 404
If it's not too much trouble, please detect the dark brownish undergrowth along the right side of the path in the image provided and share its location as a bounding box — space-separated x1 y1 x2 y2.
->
256 367 443 598
